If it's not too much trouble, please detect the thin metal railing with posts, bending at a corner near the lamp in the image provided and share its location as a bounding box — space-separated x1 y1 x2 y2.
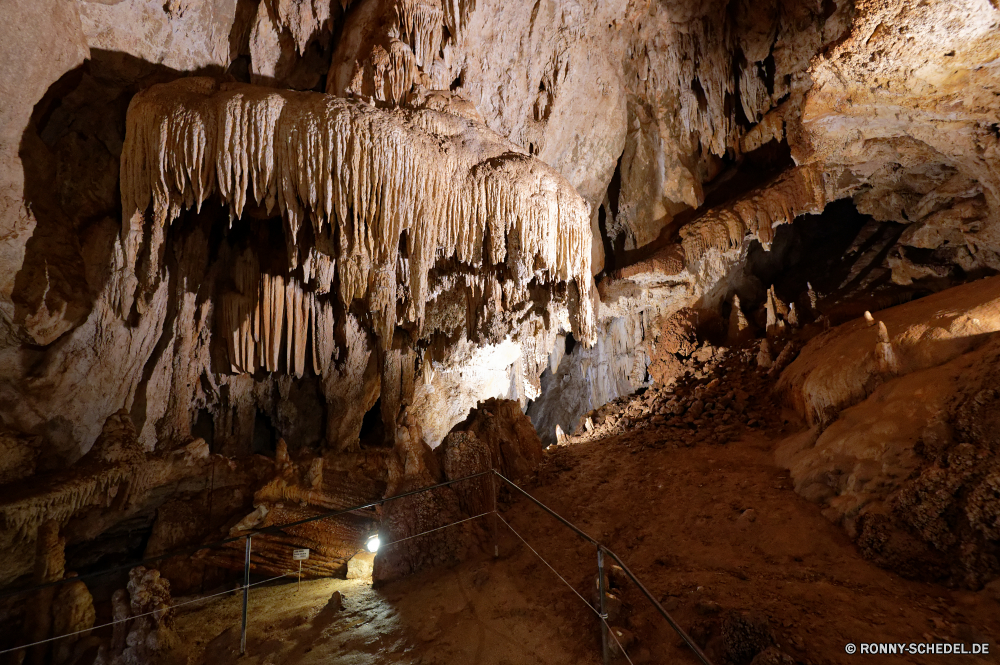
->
0 469 712 665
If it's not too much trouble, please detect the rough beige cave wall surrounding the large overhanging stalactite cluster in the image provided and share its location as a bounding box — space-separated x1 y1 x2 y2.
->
0 0 1000 572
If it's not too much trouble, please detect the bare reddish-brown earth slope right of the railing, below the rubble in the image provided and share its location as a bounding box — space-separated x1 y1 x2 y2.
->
533 422 1000 664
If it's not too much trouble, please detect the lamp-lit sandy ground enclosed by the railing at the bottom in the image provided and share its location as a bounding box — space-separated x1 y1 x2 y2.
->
176 555 599 665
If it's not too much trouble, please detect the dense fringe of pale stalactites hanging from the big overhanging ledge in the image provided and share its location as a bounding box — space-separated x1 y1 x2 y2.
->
121 78 593 352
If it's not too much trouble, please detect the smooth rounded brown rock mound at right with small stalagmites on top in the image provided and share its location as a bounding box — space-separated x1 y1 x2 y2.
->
777 277 1000 588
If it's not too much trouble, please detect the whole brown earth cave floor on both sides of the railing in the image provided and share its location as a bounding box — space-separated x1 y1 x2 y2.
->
177 419 1000 665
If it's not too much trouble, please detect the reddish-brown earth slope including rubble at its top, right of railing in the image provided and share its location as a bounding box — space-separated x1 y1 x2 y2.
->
512 350 1000 664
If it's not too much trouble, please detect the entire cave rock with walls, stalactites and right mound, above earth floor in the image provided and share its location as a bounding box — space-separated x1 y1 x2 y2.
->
0 0 1000 644
